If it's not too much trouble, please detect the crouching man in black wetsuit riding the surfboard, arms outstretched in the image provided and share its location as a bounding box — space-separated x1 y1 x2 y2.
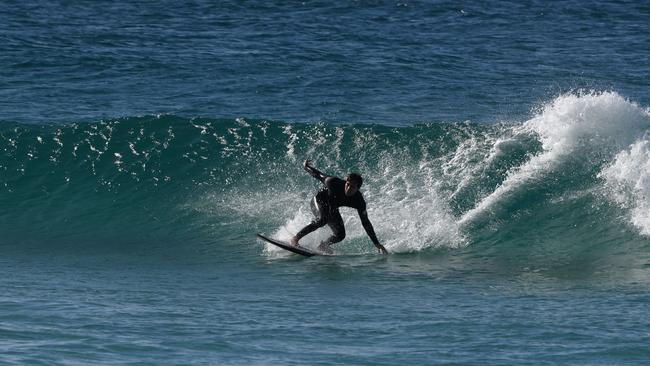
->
291 160 388 254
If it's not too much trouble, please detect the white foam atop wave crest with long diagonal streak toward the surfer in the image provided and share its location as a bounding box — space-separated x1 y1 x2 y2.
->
460 92 648 224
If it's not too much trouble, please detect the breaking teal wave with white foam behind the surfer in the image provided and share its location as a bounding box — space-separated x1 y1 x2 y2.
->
0 92 650 256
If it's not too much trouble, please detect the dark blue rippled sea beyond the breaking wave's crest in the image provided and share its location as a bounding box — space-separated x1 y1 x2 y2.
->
0 1 650 125
